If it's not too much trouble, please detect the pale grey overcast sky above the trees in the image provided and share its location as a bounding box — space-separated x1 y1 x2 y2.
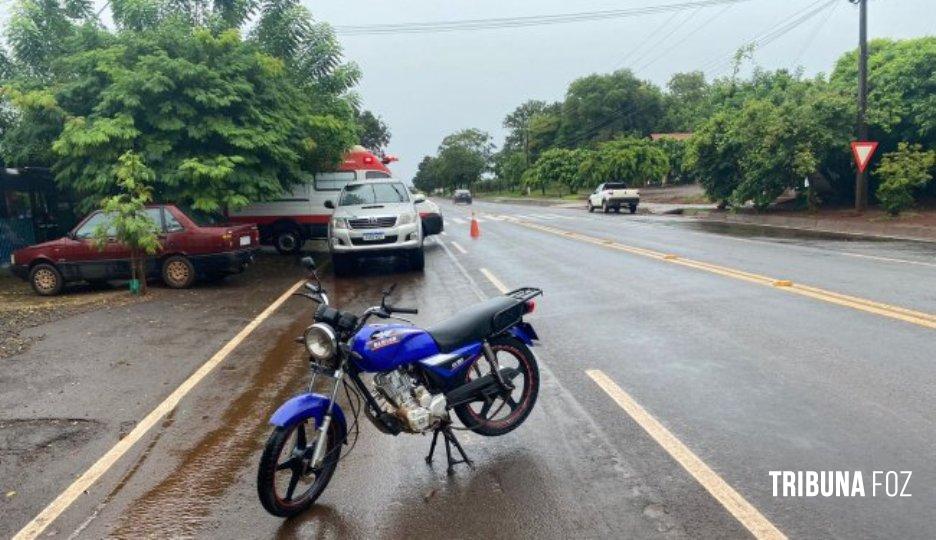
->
304 0 936 180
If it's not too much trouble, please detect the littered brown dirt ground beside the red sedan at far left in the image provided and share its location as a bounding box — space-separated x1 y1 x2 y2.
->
0 270 148 359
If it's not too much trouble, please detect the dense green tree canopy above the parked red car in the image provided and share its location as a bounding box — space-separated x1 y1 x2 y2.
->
0 0 359 210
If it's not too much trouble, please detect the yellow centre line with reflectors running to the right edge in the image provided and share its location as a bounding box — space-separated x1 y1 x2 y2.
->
511 219 936 330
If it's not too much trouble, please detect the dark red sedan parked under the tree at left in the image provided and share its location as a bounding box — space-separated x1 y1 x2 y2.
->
10 205 260 296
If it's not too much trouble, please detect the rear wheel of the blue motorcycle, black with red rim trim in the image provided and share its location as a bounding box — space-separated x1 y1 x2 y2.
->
454 336 539 437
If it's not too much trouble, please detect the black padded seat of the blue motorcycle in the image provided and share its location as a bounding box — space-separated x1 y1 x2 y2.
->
426 296 523 353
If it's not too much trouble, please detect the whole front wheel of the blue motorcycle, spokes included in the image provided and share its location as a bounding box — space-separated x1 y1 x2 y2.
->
257 419 342 517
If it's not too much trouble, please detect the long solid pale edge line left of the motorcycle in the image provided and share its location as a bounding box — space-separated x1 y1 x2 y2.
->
13 281 304 540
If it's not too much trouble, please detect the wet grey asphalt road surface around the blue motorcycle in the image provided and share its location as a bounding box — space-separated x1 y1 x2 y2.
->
0 203 936 538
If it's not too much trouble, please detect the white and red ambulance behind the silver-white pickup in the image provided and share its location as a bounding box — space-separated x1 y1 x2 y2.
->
229 146 442 253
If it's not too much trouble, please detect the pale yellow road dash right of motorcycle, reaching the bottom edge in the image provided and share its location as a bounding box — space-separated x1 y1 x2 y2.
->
585 369 786 540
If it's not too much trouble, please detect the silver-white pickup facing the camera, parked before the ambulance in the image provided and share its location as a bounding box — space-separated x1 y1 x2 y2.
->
325 179 426 276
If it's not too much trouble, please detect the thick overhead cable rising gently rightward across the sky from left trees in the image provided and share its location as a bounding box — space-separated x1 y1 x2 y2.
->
335 0 752 36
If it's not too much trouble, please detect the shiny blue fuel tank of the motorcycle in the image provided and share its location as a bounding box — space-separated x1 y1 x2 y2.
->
351 324 439 372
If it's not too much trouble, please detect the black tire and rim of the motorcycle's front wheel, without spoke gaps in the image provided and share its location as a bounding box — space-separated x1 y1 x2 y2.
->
257 421 343 517
